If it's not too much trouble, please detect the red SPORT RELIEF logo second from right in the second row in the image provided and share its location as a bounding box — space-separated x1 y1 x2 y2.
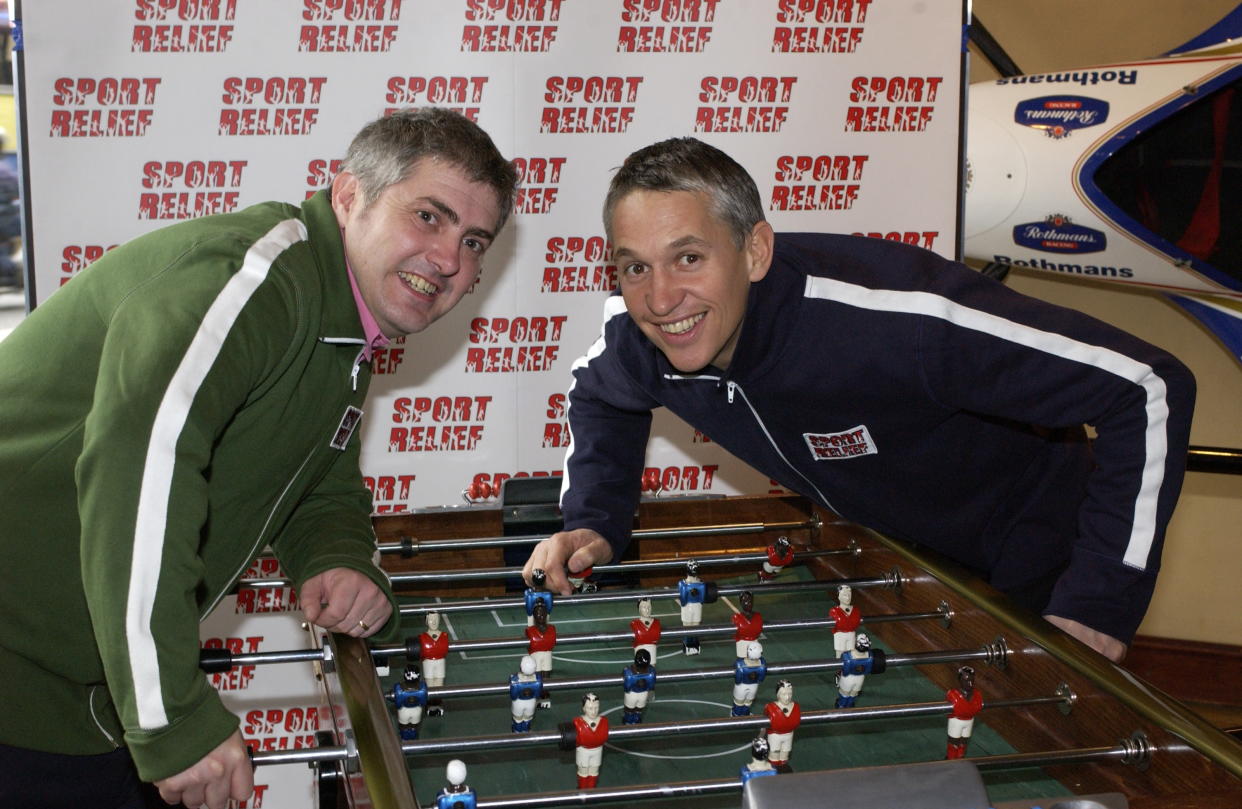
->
694 76 797 132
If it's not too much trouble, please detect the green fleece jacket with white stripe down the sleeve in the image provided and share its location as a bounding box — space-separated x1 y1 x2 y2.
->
0 193 397 780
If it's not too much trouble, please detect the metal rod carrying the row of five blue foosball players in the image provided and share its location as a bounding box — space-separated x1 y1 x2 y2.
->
412 638 1009 700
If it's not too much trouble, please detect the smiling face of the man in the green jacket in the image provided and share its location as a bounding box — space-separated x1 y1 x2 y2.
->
332 158 501 338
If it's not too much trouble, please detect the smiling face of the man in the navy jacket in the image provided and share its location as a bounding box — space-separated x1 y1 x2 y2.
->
611 190 773 373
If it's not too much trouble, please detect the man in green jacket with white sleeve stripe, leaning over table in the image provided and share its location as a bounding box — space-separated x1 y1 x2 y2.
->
0 109 517 809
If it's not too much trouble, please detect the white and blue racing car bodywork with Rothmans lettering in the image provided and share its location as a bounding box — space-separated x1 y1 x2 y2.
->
965 5 1242 359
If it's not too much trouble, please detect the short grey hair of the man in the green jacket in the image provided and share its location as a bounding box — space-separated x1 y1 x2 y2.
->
340 107 518 231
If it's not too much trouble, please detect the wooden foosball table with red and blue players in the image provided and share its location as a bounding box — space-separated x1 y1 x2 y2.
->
279 495 1242 809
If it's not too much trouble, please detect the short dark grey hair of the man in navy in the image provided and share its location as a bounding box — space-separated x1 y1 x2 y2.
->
604 138 764 250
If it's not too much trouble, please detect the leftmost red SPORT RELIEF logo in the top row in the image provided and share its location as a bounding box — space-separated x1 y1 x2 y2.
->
129 0 237 53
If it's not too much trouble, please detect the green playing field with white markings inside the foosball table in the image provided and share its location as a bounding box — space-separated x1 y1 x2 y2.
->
381 570 1067 809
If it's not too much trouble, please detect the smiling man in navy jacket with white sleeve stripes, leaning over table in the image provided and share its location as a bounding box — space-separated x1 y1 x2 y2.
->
530 138 1194 659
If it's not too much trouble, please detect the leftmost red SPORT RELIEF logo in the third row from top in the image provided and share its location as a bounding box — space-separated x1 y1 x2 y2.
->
138 159 247 219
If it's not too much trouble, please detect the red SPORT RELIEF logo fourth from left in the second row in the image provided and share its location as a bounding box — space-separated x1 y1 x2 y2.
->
539 76 643 134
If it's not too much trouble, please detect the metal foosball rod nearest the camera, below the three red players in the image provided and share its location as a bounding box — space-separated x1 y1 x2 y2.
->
439 733 1154 809
